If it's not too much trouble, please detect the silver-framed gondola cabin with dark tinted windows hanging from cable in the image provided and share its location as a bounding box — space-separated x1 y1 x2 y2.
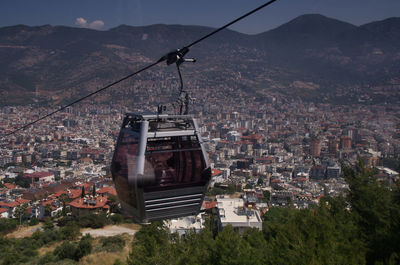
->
111 113 211 223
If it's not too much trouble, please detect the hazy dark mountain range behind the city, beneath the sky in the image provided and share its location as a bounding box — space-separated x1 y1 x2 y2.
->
0 14 400 105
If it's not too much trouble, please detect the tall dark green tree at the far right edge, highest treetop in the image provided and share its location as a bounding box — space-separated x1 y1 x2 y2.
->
343 159 400 264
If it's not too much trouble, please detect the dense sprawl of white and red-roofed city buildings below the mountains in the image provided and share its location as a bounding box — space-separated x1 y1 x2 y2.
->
0 86 400 221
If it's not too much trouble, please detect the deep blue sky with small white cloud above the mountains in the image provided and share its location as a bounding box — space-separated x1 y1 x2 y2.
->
0 0 400 34
